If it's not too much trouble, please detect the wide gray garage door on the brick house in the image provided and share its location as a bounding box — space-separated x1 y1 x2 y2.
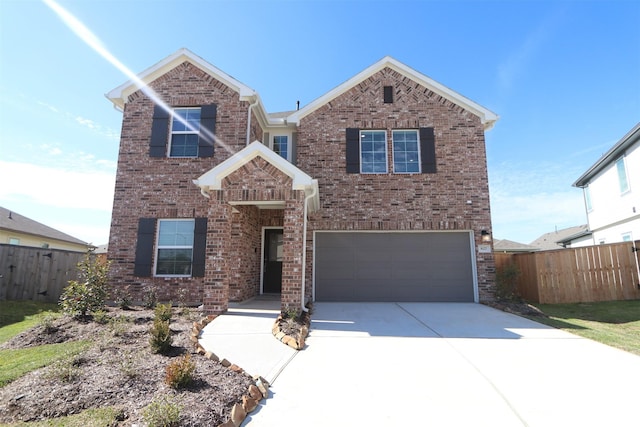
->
315 232 474 302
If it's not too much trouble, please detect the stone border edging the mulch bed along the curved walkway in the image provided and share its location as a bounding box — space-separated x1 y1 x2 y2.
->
189 315 270 427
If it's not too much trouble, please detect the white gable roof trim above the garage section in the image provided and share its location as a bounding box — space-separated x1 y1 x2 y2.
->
287 56 499 130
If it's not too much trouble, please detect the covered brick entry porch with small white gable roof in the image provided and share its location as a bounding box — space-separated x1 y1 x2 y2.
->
194 141 319 313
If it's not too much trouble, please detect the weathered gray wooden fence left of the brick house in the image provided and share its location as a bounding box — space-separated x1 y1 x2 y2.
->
0 244 85 302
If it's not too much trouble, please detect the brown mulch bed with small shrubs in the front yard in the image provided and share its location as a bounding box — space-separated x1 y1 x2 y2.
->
0 308 253 426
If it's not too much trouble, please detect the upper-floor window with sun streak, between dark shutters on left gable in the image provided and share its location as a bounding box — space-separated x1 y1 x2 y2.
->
169 108 200 157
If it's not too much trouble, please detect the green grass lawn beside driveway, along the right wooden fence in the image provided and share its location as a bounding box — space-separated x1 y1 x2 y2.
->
531 300 640 356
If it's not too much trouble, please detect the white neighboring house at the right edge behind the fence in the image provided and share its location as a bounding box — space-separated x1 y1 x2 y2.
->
573 123 640 244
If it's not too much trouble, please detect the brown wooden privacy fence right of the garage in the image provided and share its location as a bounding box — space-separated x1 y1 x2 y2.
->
495 241 640 304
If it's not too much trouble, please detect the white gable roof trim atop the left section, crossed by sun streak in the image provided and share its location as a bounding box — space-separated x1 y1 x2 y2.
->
105 48 257 110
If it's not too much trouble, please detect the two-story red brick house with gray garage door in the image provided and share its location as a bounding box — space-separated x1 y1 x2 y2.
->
107 49 498 313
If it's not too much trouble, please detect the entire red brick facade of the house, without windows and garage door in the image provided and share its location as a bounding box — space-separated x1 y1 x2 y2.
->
109 52 494 312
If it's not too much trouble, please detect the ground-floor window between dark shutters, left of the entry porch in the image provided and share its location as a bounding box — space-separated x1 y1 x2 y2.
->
156 219 195 276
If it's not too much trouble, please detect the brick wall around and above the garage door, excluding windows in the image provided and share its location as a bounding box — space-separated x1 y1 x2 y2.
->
298 68 495 300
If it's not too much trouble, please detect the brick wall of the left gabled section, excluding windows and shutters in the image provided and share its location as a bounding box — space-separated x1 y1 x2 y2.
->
108 62 255 304
